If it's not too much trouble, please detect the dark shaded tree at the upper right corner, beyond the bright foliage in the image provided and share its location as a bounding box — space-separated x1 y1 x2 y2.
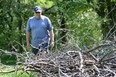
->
87 0 116 40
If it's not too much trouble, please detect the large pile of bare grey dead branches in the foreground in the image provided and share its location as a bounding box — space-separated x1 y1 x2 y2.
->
0 43 116 77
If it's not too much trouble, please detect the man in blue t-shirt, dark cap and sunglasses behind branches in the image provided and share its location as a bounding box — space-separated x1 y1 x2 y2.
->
26 6 54 55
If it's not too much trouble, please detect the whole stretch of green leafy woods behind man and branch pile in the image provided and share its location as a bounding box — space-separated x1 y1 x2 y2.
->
0 0 116 52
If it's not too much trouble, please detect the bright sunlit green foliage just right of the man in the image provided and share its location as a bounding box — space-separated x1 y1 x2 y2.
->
49 0 102 47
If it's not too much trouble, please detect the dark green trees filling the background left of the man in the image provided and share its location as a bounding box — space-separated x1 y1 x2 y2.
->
0 0 34 52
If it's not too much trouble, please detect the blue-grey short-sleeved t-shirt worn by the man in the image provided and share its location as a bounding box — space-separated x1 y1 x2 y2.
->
26 15 53 48
